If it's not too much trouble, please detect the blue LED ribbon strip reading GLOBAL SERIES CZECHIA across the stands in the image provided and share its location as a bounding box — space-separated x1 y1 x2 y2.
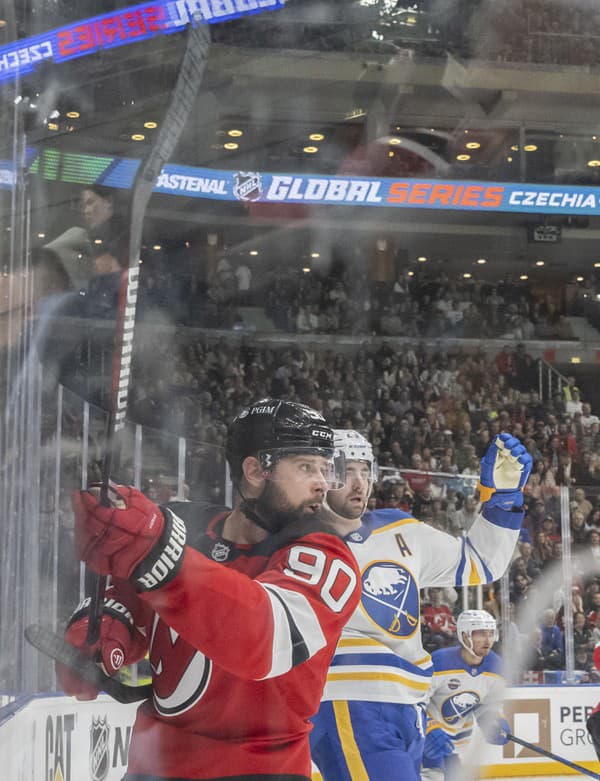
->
0 148 600 215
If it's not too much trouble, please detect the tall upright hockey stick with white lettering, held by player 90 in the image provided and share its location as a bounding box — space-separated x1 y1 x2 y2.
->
86 15 210 645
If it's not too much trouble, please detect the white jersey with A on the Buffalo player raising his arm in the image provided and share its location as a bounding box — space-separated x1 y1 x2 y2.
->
322 507 523 704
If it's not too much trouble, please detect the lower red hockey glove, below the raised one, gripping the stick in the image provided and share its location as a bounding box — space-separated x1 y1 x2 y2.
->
56 597 146 700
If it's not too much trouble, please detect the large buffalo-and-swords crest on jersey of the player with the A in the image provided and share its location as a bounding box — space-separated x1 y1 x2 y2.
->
361 561 419 637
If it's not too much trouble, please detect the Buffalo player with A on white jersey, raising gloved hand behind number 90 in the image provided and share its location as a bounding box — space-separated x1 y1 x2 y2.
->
311 430 531 781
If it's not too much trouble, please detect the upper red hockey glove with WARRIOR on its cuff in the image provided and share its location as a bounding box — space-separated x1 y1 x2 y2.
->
72 486 186 591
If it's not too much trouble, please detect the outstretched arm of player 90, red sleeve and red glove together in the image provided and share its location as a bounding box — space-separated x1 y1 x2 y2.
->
74 486 360 680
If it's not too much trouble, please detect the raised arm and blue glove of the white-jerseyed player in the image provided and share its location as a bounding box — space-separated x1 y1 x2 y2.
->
422 433 532 586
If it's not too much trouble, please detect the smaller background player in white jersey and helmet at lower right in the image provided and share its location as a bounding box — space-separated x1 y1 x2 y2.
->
421 610 510 781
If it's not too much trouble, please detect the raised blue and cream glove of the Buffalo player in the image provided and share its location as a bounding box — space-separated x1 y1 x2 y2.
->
477 433 533 510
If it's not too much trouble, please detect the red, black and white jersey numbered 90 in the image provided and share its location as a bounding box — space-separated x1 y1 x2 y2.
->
112 503 360 781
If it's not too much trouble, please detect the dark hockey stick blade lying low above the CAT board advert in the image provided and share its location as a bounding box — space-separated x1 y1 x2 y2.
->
25 624 152 703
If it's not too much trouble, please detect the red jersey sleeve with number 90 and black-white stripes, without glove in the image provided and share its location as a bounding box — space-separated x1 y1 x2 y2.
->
140 532 360 680
